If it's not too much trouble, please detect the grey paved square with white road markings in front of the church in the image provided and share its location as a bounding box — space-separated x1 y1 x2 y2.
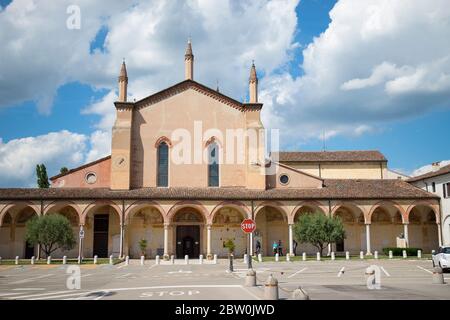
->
0 259 450 300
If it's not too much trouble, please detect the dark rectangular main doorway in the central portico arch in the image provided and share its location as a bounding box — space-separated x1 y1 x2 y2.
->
177 226 200 259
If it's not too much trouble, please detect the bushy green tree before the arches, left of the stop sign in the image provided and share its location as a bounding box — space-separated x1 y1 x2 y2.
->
25 214 76 257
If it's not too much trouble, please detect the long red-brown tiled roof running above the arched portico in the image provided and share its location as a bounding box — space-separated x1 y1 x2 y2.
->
0 180 438 200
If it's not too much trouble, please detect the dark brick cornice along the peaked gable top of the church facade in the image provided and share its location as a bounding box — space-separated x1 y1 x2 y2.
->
114 79 262 112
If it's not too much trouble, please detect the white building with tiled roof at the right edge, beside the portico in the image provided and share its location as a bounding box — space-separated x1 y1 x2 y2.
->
408 162 450 246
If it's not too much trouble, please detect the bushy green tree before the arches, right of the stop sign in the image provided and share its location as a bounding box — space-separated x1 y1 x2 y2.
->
294 212 346 255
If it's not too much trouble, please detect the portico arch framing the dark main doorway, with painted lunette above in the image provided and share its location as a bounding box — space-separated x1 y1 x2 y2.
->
172 207 205 259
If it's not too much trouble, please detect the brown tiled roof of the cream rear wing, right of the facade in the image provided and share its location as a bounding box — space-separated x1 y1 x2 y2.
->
278 150 387 162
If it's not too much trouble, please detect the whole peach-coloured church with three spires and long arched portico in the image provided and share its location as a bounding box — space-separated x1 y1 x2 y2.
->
0 42 442 259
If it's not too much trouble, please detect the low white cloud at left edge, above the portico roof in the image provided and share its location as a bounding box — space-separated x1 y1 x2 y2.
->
0 130 87 187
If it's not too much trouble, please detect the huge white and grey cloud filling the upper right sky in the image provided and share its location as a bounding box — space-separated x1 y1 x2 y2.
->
261 0 450 142
